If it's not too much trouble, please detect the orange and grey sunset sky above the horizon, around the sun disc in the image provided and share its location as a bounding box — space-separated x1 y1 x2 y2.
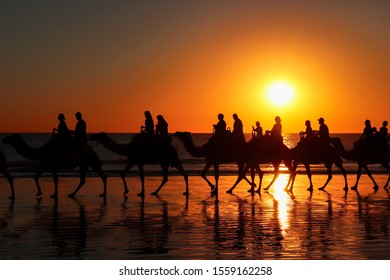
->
0 0 390 132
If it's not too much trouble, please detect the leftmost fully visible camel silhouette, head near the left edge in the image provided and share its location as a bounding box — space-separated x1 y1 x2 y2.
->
3 134 107 198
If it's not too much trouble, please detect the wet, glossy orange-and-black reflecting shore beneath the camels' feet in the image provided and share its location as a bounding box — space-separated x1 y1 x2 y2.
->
0 174 390 260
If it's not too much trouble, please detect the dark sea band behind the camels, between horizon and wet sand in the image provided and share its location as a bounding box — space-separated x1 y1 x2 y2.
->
0 133 385 177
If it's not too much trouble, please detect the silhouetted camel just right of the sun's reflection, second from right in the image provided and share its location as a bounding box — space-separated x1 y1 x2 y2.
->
287 142 348 191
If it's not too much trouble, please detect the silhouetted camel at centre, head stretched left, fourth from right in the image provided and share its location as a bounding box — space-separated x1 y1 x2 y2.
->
174 132 246 194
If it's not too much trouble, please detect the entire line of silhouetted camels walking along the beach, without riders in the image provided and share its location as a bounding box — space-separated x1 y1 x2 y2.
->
0 118 390 199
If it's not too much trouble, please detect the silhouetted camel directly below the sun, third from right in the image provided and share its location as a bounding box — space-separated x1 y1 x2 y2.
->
227 137 291 193
